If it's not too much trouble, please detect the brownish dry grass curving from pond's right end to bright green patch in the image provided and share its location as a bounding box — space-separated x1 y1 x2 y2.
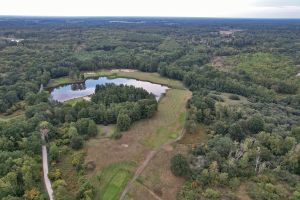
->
85 89 191 179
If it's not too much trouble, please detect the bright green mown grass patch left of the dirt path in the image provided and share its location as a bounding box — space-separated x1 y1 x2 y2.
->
91 162 135 200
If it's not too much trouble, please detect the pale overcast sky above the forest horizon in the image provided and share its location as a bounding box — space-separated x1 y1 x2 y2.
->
0 0 300 18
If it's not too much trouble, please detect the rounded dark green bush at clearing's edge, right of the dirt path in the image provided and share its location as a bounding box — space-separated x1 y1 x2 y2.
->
171 154 191 178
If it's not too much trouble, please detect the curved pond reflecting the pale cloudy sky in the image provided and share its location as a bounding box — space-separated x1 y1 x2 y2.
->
50 77 169 102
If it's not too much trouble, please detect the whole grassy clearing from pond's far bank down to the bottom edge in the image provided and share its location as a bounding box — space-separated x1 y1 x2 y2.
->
57 70 197 200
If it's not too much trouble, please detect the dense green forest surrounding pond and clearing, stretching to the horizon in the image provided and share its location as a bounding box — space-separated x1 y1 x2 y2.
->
0 17 300 200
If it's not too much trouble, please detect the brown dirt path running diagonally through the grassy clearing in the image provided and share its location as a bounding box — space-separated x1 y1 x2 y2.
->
119 129 184 200
